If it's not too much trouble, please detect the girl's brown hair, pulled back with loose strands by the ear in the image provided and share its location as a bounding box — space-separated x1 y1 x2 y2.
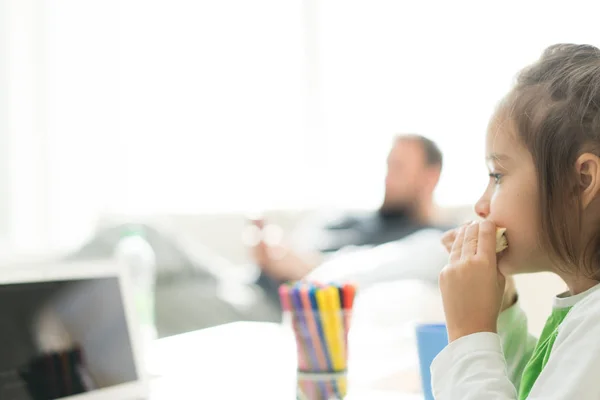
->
501 44 600 279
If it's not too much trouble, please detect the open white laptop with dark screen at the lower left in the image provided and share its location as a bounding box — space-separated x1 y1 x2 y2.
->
0 261 149 400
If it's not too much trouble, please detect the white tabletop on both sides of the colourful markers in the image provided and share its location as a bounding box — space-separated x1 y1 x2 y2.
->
151 322 423 400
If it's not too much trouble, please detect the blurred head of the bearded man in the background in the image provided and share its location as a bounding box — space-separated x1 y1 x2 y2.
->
382 134 442 210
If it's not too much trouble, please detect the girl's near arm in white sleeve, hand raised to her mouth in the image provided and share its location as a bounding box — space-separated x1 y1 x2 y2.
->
431 221 527 400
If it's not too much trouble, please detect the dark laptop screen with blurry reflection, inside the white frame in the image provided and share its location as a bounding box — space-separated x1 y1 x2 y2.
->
0 277 138 400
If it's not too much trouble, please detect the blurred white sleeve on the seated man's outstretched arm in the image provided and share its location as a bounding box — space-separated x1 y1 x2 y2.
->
309 229 448 288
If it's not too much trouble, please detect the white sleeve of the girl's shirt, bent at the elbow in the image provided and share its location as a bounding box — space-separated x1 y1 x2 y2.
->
431 292 600 400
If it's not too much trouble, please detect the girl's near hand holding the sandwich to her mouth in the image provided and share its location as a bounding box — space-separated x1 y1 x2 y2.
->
440 221 506 341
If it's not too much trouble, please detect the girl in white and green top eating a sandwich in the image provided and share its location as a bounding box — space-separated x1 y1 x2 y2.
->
431 44 600 400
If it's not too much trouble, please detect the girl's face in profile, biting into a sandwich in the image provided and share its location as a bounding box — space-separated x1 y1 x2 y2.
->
475 115 550 275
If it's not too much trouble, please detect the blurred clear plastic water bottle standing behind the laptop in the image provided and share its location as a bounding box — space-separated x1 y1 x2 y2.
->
115 228 157 348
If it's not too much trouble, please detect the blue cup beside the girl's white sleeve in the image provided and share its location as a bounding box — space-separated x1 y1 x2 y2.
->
416 324 448 400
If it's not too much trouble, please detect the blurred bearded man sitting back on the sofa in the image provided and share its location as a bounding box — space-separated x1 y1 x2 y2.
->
251 135 447 304
